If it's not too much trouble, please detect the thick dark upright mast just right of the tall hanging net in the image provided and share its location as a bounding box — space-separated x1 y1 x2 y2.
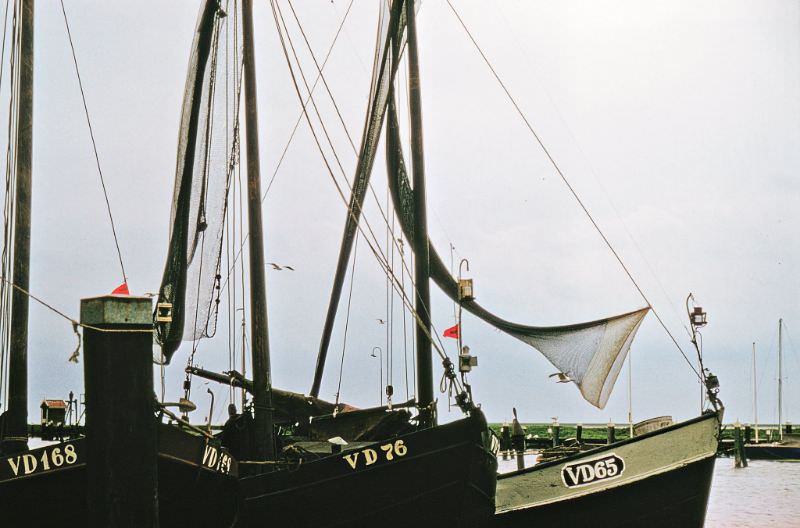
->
242 0 275 460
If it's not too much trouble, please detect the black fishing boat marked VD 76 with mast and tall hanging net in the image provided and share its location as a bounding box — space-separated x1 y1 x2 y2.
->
157 0 497 527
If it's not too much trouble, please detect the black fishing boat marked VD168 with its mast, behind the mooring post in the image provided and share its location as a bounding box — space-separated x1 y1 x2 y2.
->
0 0 240 528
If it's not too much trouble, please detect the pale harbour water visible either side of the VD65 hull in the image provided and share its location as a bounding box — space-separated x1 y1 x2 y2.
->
498 455 800 528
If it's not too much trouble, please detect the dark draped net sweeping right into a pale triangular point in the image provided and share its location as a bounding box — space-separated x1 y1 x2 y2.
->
386 94 649 409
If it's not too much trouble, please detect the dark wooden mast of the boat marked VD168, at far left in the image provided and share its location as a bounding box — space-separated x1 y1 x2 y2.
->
2 0 33 453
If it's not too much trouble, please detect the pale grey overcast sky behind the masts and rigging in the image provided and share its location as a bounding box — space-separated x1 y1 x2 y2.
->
7 0 800 423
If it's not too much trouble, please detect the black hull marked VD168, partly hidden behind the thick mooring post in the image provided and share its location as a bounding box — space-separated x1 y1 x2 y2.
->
0 426 240 528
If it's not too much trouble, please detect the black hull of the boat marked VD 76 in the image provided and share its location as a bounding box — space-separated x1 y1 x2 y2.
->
238 415 497 528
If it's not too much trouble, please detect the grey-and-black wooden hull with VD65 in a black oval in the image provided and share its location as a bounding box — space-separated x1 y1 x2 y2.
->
493 413 720 528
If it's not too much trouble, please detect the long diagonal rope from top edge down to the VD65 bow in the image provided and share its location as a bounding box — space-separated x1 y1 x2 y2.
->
447 0 702 379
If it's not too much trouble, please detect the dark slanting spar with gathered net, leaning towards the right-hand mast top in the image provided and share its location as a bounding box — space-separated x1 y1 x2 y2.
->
310 0 405 396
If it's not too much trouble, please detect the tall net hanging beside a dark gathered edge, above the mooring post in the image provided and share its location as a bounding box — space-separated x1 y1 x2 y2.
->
155 0 240 363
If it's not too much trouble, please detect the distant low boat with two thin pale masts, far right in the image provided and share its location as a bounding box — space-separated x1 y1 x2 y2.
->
744 319 800 460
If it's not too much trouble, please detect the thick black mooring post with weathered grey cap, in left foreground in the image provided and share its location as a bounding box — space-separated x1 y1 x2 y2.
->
81 295 158 528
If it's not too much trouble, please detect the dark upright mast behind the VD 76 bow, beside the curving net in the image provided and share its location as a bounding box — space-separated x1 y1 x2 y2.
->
406 0 436 427
